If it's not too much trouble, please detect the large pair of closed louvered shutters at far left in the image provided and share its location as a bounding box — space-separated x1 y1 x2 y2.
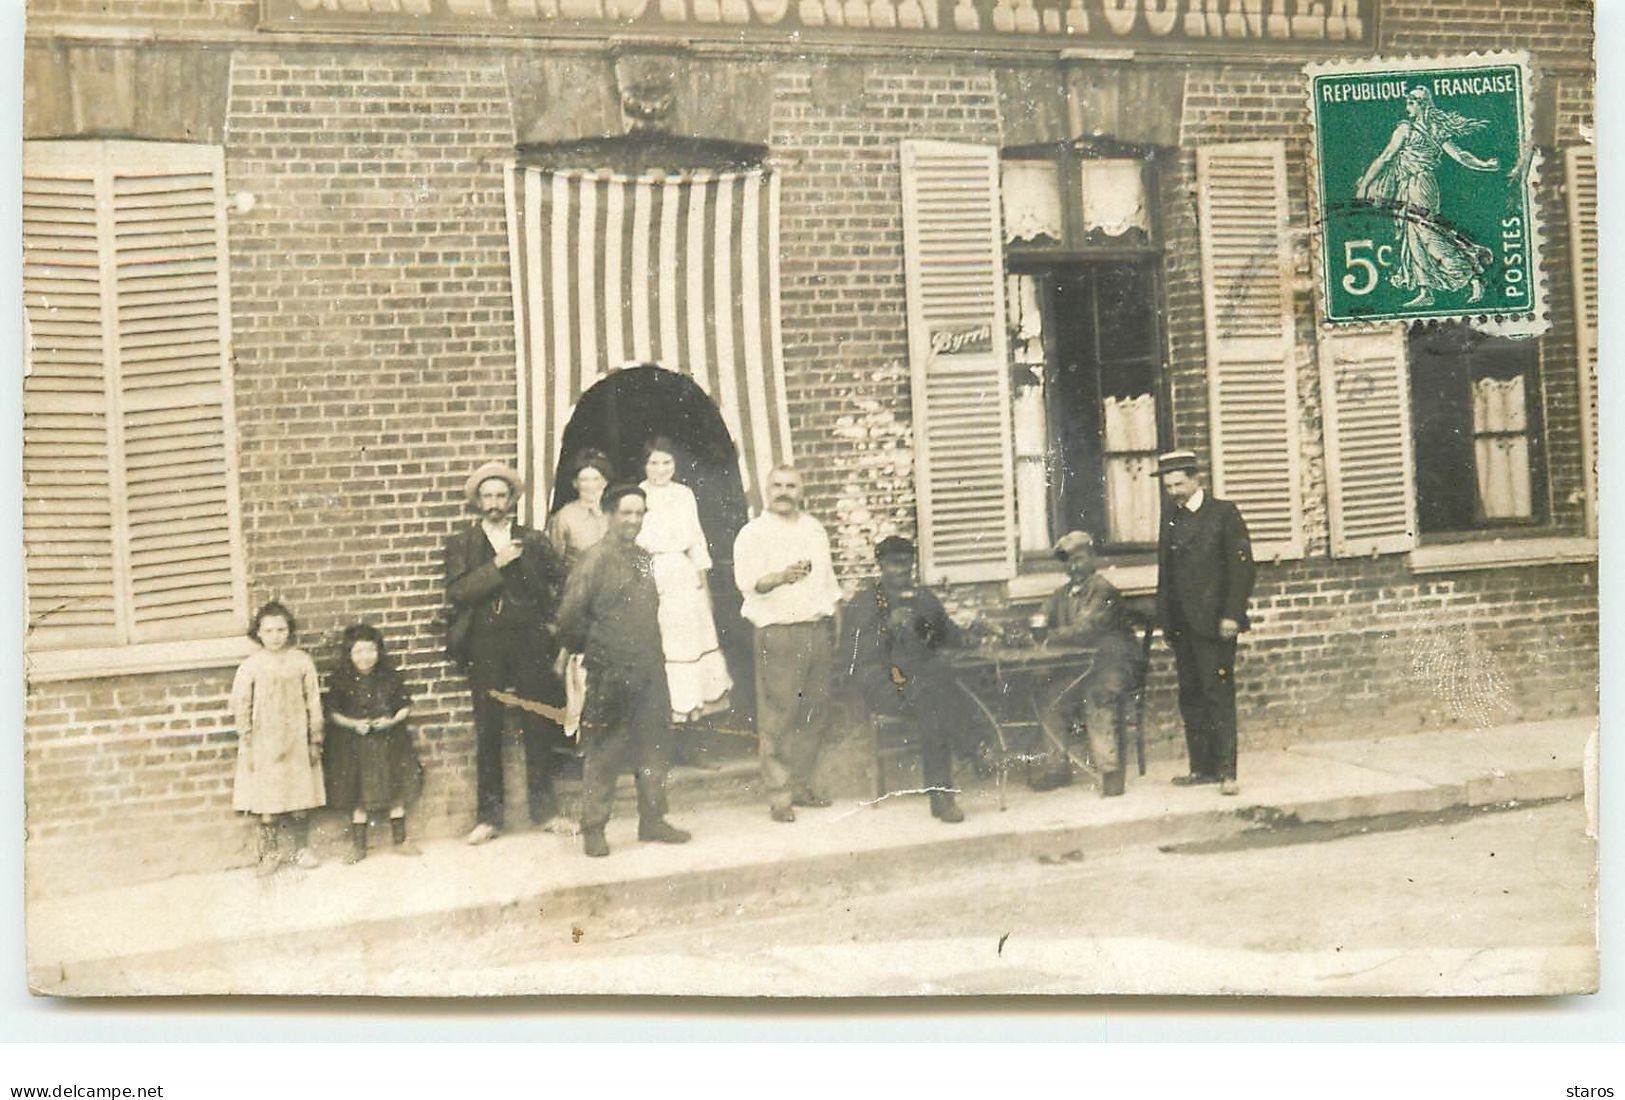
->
23 141 247 678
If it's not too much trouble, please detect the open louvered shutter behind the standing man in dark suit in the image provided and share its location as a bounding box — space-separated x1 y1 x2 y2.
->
1196 141 1303 559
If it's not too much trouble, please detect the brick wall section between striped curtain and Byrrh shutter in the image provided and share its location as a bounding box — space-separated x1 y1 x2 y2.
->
770 62 999 577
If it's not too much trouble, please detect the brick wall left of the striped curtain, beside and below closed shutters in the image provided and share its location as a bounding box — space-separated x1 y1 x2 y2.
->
28 50 517 896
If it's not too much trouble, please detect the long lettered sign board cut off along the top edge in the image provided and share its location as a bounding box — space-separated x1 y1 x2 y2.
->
262 0 1380 52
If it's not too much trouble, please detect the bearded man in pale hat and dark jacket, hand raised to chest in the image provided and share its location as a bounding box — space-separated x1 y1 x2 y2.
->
445 461 567 845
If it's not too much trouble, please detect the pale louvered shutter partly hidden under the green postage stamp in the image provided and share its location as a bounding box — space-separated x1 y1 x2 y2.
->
1320 325 1415 557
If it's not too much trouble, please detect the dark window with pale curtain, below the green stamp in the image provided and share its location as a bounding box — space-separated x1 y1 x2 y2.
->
1409 325 1547 538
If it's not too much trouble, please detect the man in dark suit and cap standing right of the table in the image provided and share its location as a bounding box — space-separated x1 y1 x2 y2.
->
1157 450 1253 795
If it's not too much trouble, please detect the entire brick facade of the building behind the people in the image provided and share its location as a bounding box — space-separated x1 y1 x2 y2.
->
24 0 1597 882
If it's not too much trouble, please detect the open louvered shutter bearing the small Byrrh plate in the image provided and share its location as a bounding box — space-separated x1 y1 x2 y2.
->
902 141 1016 583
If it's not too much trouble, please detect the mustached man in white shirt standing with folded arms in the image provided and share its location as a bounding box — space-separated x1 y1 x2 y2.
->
733 466 840 822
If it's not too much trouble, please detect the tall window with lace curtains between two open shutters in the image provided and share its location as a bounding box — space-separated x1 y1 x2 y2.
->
1001 140 1167 569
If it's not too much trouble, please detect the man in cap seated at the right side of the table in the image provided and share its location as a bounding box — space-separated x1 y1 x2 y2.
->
1032 531 1139 798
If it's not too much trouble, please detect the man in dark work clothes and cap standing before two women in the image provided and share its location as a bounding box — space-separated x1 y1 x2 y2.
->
559 486 689 856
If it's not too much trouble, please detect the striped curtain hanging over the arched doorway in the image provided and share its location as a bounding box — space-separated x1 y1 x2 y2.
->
507 166 790 513
